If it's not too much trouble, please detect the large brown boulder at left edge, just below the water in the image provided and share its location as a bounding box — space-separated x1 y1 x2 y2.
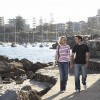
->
0 61 26 79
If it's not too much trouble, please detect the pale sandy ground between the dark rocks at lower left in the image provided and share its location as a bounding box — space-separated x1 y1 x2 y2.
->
0 79 50 95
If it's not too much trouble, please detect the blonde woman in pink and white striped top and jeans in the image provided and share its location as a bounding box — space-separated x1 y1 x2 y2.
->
55 36 70 92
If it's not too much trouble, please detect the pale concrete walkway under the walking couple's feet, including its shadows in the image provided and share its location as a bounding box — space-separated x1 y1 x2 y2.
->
42 73 100 100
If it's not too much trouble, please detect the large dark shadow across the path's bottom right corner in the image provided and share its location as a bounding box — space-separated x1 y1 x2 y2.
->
59 79 100 100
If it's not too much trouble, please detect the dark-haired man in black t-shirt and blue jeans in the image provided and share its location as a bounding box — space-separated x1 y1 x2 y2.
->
71 35 89 92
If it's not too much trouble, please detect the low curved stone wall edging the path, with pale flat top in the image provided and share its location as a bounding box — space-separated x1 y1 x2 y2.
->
35 67 59 96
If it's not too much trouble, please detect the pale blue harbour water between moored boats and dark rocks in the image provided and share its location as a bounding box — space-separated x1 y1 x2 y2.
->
0 43 55 63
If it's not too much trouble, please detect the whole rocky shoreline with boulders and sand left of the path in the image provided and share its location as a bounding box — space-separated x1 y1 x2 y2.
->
0 56 57 100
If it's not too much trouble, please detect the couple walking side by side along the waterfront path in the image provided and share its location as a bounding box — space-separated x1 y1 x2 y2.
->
55 35 89 92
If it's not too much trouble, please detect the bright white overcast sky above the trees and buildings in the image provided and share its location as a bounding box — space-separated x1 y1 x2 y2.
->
0 0 100 24
